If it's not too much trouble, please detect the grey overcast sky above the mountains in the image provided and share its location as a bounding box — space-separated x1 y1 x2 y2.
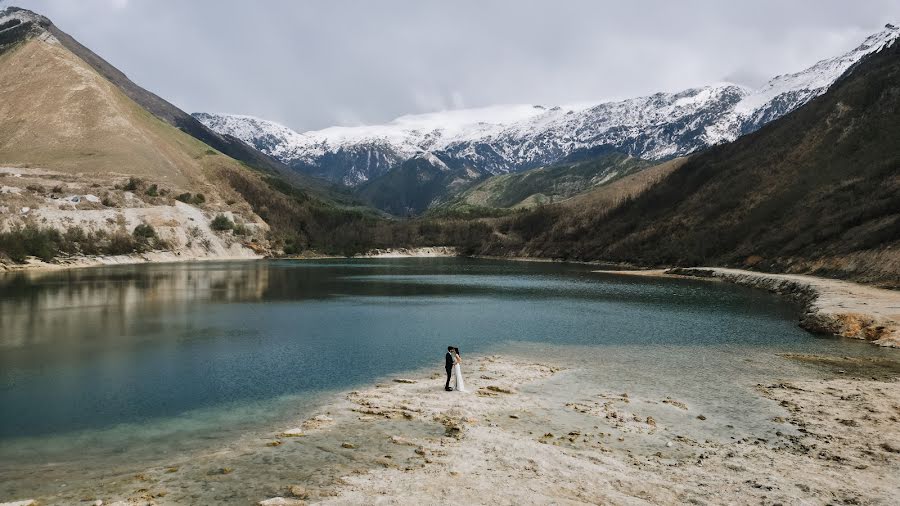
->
8 0 900 131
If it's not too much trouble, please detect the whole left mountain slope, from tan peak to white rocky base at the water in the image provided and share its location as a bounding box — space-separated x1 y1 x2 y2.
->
0 9 390 263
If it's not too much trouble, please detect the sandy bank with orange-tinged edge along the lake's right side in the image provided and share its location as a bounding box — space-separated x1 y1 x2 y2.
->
594 267 900 348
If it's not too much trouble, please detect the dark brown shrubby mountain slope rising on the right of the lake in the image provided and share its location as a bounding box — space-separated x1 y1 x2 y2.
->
482 29 900 286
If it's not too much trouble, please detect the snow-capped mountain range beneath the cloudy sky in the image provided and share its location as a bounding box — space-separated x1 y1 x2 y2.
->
194 25 900 186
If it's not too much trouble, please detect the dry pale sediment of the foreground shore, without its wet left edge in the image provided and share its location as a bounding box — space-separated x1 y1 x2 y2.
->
261 357 900 505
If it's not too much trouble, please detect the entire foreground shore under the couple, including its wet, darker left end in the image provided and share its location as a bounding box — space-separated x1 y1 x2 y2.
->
7 350 900 505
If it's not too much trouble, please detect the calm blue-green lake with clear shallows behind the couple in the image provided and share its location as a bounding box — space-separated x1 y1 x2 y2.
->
0 259 892 499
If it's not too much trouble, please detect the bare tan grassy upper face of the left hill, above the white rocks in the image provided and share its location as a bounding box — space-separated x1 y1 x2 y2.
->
0 37 234 187
